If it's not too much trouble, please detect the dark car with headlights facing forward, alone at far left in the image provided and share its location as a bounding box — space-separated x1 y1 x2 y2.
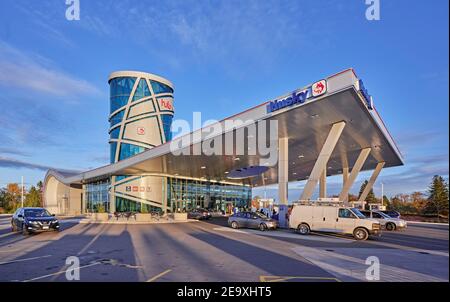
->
11 208 60 235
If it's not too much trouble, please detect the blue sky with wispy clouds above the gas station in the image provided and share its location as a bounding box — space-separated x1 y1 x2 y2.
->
0 0 449 199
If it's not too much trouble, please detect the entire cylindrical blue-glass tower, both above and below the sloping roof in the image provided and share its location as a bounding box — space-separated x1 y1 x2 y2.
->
108 71 174 212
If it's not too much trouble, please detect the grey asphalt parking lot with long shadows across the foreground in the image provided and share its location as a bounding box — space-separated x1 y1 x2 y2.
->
0 217 449 282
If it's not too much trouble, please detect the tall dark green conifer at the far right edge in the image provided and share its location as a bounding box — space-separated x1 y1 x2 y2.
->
426 175 449 218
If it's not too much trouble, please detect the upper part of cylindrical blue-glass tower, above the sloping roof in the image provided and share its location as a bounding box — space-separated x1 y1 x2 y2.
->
108 71 174 163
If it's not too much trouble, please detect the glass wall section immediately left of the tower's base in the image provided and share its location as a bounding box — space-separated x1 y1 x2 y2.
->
85 178 110 213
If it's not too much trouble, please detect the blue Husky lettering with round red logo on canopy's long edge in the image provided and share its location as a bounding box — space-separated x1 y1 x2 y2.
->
267 80 327 113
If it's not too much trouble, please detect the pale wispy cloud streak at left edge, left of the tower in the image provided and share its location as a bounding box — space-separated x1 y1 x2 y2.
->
0 41 100 97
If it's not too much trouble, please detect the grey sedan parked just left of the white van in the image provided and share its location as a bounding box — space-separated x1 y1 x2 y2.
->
228 211 278 231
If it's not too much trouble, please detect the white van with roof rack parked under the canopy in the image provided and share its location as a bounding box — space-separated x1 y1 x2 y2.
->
289 204 381 240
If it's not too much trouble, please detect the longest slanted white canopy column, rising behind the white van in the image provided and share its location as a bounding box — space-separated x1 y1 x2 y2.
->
300 122 345 200
